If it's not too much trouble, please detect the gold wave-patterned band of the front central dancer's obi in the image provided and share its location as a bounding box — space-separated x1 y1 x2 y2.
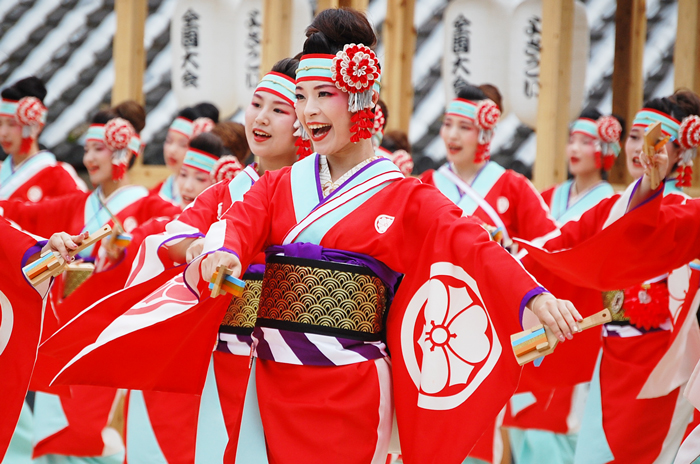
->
258 256 387 340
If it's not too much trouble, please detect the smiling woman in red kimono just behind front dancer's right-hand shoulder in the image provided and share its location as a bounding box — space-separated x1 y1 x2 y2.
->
421 85 556 243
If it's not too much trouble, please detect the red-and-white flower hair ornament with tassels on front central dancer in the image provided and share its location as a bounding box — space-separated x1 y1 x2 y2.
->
331 44 381 143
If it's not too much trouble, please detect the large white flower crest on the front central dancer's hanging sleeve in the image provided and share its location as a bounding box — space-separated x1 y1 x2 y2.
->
401 262 502 410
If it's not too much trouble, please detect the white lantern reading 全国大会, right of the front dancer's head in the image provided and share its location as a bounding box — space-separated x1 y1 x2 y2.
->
442 0 512 114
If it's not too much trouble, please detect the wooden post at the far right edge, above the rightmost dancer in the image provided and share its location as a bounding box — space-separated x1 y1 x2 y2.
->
673 0 700 94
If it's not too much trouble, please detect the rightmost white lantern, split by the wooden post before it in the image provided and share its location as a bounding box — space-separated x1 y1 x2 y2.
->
508 0 590 128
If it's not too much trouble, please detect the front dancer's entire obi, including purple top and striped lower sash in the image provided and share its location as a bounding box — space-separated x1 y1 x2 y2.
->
253 244 399 366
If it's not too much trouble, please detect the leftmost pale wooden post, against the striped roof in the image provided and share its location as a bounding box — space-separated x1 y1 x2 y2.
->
112 0 148 106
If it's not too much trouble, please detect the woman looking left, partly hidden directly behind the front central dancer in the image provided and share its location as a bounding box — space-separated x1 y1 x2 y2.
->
126 59 298 464
